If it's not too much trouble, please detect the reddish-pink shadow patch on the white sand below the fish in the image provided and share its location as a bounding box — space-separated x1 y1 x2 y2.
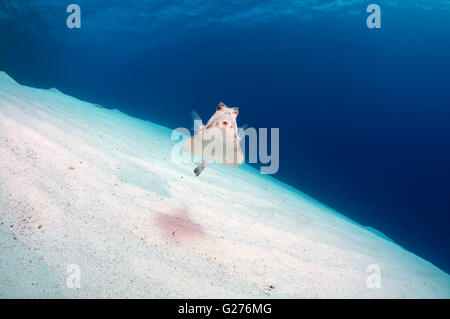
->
155 209 205 242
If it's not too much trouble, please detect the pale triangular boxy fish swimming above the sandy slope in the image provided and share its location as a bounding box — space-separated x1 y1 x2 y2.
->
183 102 244 176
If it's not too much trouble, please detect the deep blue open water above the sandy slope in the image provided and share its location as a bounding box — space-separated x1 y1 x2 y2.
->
0 0 450 273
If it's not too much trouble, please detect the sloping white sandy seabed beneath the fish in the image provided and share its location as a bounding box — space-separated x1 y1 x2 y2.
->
0 72 450 298
